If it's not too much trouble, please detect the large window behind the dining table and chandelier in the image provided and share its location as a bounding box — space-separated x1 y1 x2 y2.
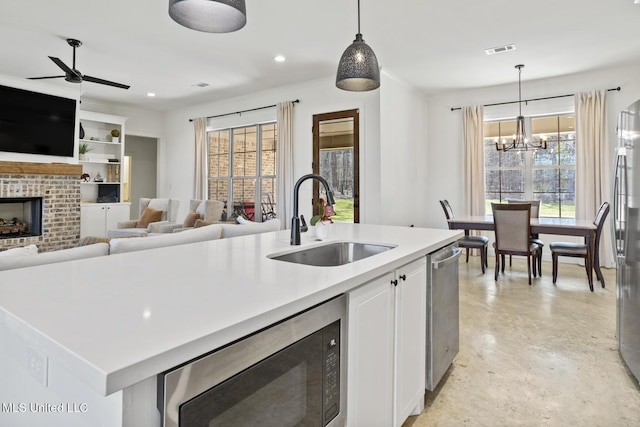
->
484 114 576 218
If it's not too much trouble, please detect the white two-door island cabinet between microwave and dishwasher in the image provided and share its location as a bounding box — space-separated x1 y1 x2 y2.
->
347 258 427 426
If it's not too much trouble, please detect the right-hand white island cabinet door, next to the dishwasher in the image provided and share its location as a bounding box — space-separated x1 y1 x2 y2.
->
394 258 427 426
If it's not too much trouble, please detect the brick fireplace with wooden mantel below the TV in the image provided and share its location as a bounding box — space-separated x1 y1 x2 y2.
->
0 162 82 252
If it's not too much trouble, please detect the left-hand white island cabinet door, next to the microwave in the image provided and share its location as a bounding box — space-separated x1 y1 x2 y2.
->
347 273 392 427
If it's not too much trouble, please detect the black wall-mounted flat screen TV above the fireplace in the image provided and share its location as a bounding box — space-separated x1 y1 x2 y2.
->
0 85 76 157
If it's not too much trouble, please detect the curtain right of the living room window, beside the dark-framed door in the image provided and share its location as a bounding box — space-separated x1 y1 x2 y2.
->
276 101 294 229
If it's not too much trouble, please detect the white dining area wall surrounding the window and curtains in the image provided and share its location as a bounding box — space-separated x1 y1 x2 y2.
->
424 63 640 228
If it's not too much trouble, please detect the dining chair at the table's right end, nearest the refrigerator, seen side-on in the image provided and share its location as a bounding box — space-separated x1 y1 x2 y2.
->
549 202 609 292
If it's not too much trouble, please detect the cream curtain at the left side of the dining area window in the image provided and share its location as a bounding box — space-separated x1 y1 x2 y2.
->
462 105 485 215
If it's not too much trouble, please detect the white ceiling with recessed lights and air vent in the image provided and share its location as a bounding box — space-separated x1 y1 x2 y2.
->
0 0 640 110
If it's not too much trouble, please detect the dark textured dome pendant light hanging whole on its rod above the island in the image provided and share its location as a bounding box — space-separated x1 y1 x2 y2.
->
336 0 380 92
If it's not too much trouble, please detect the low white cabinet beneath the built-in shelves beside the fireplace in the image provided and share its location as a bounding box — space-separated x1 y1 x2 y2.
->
80 203 131 237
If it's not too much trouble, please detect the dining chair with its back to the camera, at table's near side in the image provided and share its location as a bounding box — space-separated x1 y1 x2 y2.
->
491 203 538 285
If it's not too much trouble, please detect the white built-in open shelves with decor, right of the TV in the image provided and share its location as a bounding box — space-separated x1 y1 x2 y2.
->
78 111 126 203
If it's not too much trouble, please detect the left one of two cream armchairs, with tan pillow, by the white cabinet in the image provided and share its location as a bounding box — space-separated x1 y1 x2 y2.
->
107 197 180 237
